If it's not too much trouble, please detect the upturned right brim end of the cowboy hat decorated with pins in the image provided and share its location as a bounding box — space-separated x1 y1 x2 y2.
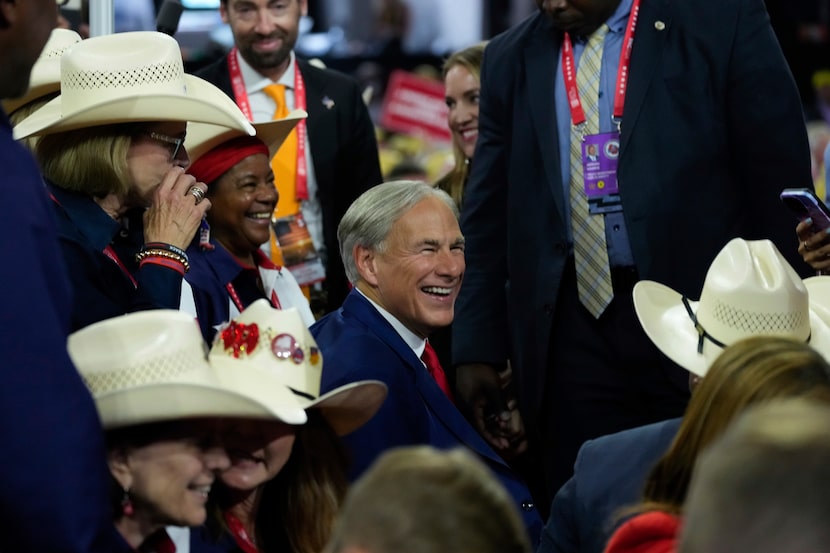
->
306 380 388 436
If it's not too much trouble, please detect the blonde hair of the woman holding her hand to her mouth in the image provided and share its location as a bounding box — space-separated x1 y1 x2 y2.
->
35 123 138 198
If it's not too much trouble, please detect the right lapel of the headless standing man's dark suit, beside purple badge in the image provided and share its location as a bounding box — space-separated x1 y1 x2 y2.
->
620 0 671 151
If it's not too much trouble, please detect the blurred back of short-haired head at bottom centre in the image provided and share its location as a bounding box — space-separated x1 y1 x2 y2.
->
326 446 531 553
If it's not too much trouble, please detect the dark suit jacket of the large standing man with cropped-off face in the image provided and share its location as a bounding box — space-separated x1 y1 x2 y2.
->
453 0 812 421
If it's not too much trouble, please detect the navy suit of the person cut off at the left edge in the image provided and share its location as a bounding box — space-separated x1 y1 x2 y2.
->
0 141 123 553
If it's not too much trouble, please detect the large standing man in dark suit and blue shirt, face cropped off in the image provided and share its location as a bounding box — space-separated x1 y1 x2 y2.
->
453 0 811 501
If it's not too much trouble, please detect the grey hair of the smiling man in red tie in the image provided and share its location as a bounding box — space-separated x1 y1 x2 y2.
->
337 180 458 284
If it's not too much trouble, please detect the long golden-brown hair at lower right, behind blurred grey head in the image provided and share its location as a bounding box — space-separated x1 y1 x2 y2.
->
645 336 830 511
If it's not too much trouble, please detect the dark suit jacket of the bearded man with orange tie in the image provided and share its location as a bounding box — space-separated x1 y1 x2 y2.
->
196 56 383 311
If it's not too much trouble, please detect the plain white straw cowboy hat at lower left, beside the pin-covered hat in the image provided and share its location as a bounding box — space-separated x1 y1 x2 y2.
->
68 309 307 429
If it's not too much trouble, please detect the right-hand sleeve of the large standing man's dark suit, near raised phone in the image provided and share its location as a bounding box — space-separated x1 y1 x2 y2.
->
728 0 812 276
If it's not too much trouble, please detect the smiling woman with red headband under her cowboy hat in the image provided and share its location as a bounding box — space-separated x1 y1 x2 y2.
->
181 110 314 343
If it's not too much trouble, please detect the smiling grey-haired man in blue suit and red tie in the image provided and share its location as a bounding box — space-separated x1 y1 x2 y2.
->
311 181 542 544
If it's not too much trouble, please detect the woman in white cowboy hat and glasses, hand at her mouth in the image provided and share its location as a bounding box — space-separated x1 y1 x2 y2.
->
15 32 253 329
